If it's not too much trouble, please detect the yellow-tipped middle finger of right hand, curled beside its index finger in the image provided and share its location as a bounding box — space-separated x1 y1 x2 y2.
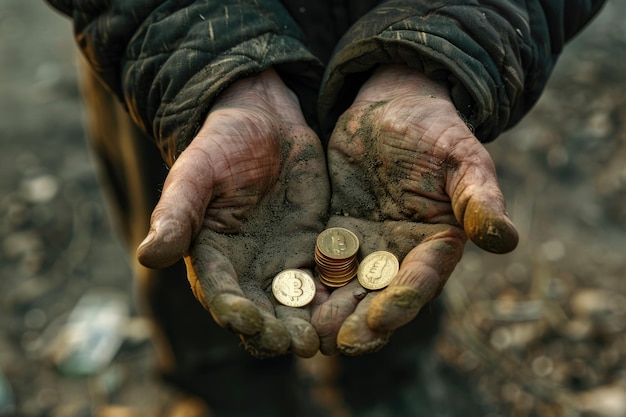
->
337 292 392 356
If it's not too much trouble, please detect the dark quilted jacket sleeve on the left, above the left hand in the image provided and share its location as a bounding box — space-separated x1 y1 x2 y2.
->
48 0 321 164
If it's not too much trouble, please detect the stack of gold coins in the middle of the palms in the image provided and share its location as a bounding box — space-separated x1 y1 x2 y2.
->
315 227 359 288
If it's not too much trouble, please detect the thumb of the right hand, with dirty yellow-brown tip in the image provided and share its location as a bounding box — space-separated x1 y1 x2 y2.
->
447 137 519 253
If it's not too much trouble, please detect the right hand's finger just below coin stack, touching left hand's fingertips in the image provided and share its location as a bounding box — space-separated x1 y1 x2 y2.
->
311 280 366 355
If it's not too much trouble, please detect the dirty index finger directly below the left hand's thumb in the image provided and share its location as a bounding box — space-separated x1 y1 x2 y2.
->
185 242 265 335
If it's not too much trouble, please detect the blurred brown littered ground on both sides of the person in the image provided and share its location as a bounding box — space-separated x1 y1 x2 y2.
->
0 0 626 417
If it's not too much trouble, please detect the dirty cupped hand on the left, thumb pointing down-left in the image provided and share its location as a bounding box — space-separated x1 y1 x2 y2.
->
138 70 330 357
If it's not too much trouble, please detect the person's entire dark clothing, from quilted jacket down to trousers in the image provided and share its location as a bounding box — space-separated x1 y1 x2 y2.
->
48 0 603 417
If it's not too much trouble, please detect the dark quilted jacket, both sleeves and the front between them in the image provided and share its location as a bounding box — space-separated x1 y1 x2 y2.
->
48 0 604 164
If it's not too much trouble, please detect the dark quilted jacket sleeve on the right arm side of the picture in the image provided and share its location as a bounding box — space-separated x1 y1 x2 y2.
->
319 0 603 142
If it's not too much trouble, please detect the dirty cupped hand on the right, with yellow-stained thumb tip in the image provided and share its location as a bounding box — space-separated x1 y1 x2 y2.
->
313 66 518 355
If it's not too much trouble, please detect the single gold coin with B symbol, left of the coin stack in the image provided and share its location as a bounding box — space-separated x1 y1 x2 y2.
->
272 268 315 307
